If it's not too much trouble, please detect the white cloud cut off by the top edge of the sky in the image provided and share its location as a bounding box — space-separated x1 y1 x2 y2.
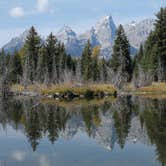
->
37 0 49 13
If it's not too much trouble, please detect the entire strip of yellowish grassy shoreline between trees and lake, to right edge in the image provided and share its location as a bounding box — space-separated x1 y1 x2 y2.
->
11 83 166 100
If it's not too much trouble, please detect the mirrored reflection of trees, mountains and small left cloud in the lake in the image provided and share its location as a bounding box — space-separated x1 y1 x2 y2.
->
0 96 166 166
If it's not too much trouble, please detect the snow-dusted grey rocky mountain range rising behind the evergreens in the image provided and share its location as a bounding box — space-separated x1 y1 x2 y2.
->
3 16 154 58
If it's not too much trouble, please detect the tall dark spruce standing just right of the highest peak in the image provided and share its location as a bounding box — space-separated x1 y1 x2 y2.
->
110 25 132 88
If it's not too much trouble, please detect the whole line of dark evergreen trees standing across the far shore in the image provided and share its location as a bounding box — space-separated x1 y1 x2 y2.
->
0 7 166 88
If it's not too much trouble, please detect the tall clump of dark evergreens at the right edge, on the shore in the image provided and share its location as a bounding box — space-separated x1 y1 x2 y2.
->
135 8 166 86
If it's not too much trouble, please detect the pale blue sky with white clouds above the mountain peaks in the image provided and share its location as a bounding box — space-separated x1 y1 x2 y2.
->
0 0 166 46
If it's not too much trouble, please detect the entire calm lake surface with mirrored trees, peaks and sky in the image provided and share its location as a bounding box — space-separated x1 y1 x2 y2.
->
0 97 166 166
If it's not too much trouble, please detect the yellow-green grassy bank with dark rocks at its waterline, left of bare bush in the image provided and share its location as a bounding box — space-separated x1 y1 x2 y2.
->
11 84 116 98
